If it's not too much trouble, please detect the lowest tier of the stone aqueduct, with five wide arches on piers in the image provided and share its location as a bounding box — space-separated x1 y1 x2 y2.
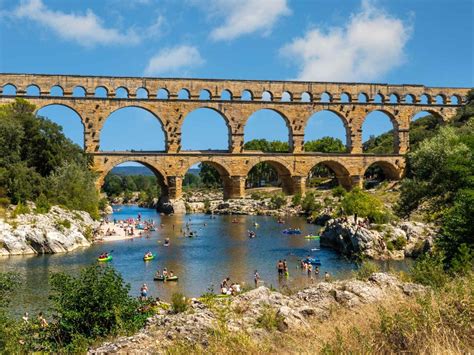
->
92 152 405 199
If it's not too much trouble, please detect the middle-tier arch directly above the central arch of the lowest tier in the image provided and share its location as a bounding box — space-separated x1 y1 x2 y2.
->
243 108 293 151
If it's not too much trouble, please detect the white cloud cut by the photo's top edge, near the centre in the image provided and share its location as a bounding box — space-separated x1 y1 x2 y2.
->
205 0 291 41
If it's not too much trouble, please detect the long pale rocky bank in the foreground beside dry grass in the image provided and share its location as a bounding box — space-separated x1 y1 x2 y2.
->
89 273 426 354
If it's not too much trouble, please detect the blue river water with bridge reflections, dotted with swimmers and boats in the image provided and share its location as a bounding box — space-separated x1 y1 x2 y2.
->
0 206 409 314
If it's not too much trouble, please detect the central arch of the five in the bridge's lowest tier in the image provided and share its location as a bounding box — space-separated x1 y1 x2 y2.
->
245 158 294 195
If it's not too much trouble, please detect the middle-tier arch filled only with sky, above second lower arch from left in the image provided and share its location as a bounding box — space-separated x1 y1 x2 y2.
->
181 107 232 151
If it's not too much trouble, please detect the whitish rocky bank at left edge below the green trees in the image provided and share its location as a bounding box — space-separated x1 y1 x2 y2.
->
0 203 99 256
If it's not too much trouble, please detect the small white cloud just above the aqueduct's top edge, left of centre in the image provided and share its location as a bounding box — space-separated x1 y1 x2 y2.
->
145 45 205 75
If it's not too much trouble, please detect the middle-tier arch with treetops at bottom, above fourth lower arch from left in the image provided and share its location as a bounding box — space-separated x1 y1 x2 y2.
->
304 110 352 153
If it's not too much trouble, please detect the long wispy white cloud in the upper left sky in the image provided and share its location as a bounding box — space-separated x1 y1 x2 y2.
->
11 0 140 47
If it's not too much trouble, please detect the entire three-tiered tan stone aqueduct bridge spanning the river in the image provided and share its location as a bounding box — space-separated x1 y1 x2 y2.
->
0 74 468 199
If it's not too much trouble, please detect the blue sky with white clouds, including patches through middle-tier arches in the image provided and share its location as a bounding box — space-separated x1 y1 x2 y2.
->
0 0 474 157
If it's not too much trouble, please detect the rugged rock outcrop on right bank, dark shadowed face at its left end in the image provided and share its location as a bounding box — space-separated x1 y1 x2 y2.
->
320 218 436 259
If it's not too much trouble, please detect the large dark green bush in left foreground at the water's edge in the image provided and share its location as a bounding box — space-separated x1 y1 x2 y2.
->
50 265 147 344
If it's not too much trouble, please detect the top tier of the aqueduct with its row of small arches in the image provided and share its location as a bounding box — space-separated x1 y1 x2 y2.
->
0 74 469 105
